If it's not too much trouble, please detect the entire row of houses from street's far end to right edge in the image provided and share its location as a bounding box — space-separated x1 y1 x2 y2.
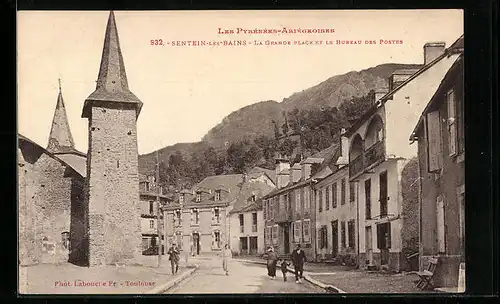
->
158 36 465 286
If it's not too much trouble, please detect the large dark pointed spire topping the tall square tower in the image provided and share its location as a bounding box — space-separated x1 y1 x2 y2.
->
82 11 142 117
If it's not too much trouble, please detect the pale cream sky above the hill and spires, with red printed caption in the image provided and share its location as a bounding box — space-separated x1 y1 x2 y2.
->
17 10 463 154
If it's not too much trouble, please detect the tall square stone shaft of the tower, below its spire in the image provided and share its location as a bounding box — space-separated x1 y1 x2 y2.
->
87 104 142 266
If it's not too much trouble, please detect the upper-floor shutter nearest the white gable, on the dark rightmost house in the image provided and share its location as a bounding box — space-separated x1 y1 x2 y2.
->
427 111 442 172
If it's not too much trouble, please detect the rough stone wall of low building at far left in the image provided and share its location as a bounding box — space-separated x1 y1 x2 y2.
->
19 141 84 265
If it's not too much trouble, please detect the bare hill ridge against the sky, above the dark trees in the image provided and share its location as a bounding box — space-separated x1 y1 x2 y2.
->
139 63 422 174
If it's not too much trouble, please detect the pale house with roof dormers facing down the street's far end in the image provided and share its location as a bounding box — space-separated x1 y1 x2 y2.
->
163 168 274 255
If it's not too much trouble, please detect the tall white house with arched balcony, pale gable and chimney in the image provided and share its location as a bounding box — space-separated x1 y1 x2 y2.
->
346 35 458 271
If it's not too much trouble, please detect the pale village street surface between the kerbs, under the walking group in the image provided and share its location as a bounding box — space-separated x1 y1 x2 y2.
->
165 256 324 294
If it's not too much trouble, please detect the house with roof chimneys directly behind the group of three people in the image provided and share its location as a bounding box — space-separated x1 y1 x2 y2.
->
262 144 338 261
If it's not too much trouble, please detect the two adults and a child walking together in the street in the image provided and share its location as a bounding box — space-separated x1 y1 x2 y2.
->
267 244 306 283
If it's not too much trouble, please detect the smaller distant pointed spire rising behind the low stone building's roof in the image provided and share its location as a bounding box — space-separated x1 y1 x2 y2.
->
47 80 76 154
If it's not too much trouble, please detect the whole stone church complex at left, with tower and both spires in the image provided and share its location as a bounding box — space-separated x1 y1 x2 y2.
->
18 12 152 266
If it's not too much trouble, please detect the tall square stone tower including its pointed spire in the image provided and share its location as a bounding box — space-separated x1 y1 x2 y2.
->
82 11 142 266
